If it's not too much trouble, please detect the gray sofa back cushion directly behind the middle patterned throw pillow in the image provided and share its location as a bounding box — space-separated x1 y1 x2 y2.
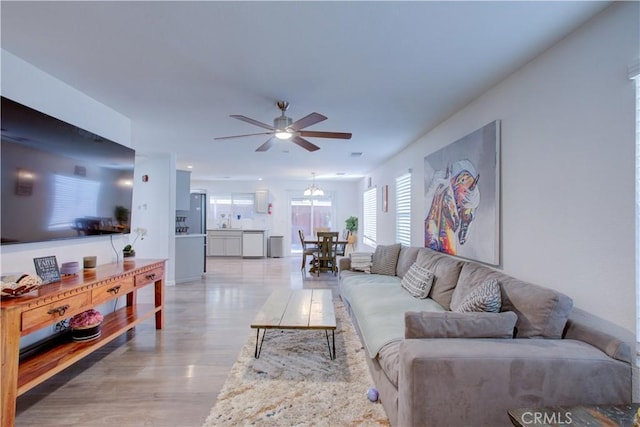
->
416 248 463 310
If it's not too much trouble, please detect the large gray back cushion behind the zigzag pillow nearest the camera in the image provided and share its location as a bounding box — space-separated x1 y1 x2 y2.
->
452 262 573 338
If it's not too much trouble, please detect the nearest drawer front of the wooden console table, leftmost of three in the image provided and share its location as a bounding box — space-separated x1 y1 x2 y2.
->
21 291 91 333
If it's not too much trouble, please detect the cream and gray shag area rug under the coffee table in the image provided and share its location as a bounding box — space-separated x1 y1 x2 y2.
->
204 301 390 427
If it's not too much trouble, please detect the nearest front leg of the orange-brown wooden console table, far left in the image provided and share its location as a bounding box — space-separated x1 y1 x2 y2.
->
0 309 20 427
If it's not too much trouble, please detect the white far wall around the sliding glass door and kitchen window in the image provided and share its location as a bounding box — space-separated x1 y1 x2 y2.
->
191 180 361 254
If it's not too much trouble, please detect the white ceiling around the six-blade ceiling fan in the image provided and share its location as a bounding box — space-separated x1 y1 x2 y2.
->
0 0 609 180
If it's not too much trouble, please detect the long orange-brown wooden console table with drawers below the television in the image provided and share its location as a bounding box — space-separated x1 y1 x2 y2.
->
0 259 165 427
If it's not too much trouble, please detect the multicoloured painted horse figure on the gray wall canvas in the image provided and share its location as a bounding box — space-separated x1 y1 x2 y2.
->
424 159 480 255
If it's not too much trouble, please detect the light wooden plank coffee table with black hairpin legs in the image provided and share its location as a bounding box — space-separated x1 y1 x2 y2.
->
251 289 336 360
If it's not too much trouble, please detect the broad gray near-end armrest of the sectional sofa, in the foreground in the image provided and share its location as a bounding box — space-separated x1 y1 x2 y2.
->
398 338 631 426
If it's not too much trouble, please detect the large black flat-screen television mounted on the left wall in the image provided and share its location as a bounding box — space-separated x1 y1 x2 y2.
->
0 97 135 245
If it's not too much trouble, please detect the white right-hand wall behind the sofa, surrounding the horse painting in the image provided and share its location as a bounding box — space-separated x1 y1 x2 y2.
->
360 2 640 331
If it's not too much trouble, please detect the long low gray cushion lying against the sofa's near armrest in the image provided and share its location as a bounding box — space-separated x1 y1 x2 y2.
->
404 311 518 338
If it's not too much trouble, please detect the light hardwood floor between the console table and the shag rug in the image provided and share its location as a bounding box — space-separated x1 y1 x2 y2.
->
16 256 338 427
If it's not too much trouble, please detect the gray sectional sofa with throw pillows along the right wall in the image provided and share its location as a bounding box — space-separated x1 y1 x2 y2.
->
339 245 635 427
